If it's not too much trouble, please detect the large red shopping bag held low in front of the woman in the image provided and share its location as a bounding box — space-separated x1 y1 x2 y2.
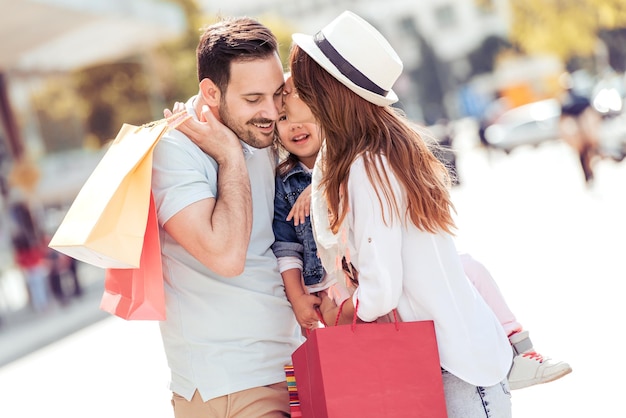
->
292 321 447 418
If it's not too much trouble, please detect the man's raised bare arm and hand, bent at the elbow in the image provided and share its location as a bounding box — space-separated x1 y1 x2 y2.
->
163 104 252 277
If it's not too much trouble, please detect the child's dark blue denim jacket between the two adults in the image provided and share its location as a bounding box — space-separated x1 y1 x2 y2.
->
272 165 324 286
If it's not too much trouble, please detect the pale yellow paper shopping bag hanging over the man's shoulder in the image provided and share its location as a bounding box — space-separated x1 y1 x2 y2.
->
49 120 168 268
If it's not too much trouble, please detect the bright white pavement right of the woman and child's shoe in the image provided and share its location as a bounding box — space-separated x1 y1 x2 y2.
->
454 136 626 418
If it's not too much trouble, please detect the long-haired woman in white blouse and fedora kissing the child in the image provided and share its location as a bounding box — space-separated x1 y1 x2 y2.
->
285 12 512 418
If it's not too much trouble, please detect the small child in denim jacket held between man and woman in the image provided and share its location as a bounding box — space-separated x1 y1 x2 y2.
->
272 78 572 389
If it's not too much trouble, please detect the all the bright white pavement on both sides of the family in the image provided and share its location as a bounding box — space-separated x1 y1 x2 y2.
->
0 131 626 418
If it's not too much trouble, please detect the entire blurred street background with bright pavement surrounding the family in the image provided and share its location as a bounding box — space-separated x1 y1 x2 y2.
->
0 0 626 418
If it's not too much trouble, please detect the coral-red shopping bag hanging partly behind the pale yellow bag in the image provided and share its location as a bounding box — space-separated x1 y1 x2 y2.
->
100 194 165 320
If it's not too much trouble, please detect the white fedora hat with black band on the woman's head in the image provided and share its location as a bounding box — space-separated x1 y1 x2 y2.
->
292 11 402 106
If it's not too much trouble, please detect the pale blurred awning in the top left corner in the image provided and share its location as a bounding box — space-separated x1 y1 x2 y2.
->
0 0 184 74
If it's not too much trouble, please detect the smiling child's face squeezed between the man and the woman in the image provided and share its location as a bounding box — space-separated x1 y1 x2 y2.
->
276 111 322 168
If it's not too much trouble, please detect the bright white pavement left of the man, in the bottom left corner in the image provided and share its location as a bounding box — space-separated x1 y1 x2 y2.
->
0 317 173 418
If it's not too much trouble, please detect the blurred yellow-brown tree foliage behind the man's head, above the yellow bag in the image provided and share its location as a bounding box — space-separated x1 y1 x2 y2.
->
32 0 293 151
